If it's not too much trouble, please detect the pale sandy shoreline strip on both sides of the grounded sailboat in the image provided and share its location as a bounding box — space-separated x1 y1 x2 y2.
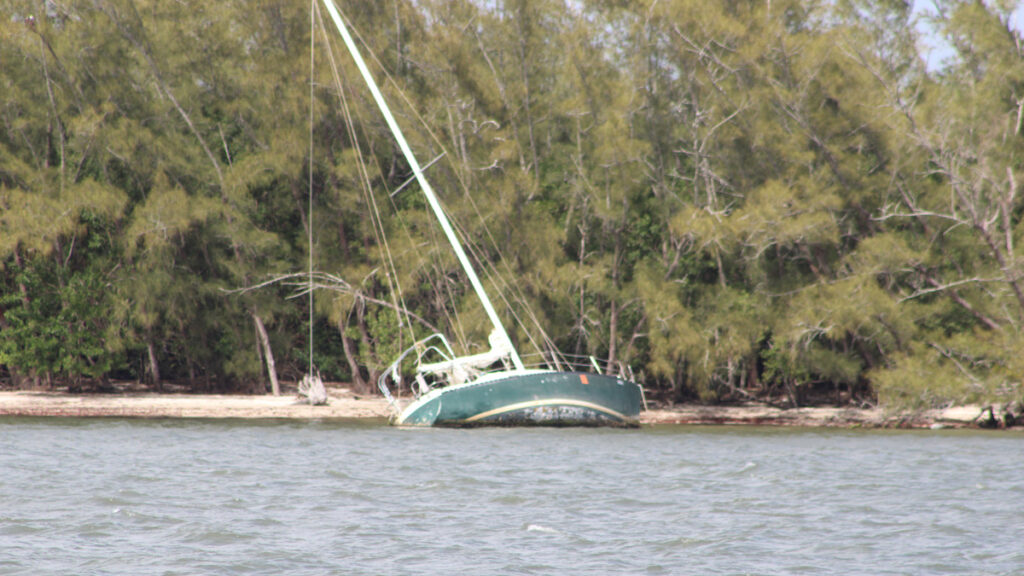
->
0 386 1024 429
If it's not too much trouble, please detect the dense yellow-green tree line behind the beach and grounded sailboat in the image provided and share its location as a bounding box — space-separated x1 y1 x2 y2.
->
0 0 1024 406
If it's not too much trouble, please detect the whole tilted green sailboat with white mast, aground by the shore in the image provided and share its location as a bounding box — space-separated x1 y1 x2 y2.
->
323 0 644 426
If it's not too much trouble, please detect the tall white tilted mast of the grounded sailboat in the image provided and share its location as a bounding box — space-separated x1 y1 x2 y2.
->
324 0 524 370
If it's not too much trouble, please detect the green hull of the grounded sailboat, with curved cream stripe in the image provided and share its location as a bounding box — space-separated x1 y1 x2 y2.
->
396 371 643 426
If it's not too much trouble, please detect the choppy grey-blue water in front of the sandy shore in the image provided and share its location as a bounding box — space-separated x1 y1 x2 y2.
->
0 419 1024 576
